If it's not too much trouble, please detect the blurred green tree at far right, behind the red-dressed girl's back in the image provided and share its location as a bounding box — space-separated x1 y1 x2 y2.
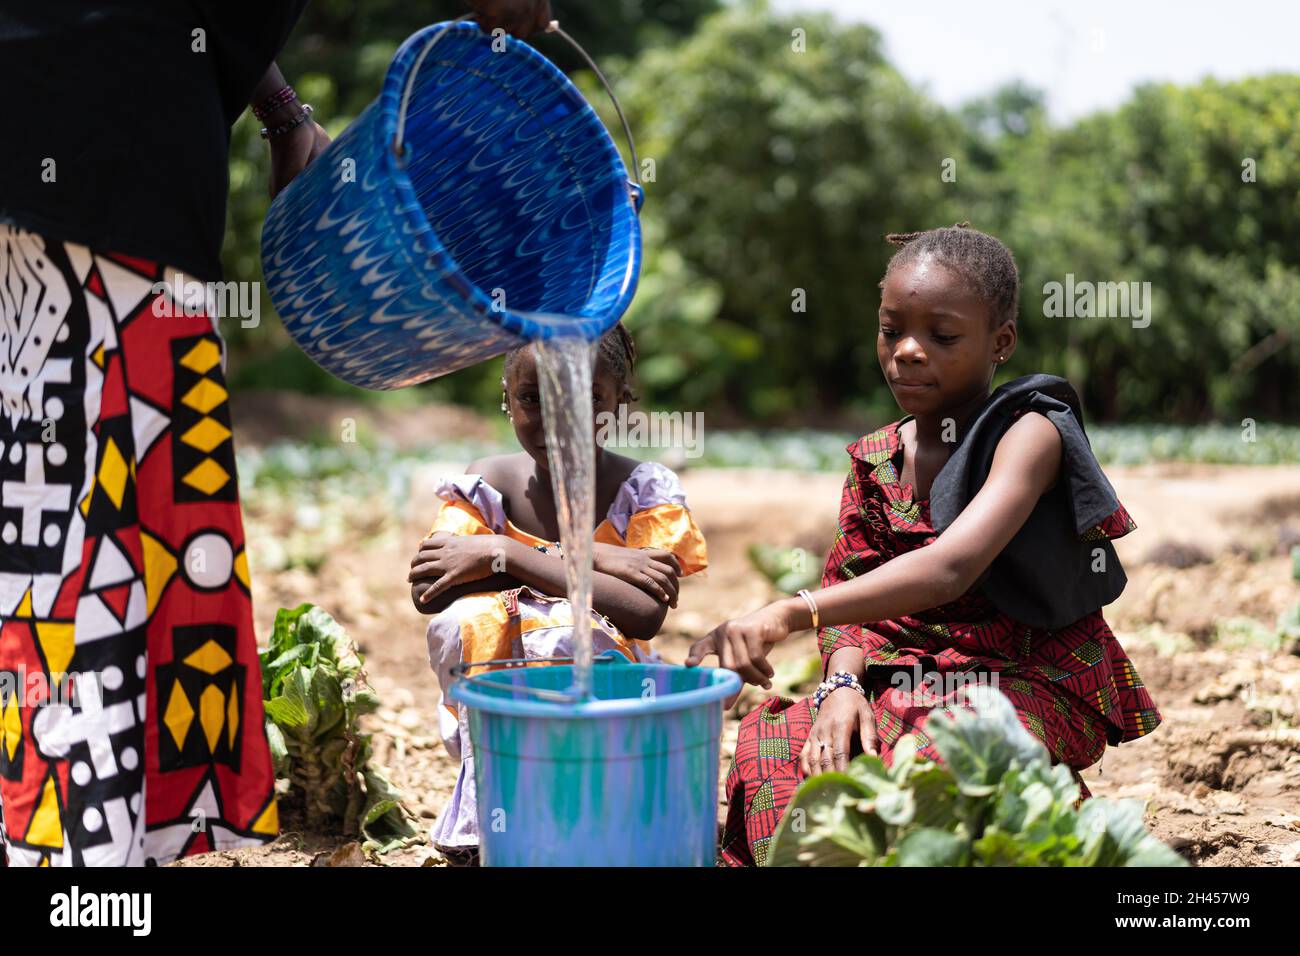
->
982 75 1300 421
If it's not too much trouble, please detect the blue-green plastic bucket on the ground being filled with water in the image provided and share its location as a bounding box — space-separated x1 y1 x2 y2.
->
450 662 740 866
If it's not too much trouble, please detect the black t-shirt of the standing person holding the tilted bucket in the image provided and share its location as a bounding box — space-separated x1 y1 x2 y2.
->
0 0 306 280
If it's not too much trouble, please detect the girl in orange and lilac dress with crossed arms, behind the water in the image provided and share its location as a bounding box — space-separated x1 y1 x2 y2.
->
410 325 709 862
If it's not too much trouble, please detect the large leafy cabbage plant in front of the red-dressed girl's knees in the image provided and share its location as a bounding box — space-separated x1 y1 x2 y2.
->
767 687 1187 866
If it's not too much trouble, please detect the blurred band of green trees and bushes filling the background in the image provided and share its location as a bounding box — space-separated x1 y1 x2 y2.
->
224 0 1300 428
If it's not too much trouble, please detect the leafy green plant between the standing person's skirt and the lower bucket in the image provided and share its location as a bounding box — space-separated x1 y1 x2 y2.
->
260 604 420 853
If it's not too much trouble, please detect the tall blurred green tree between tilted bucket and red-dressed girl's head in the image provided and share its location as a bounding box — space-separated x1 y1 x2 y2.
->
625 4 966 420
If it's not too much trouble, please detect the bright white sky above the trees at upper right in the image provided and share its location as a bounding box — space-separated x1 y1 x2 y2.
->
771 0 1300 121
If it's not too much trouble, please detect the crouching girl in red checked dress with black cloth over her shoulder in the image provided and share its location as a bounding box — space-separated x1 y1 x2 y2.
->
686 224 1161 865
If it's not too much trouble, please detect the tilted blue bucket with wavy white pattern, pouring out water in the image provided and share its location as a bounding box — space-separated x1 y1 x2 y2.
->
261 21 641 389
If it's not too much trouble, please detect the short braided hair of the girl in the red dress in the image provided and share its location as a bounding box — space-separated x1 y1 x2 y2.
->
880 221 1021 329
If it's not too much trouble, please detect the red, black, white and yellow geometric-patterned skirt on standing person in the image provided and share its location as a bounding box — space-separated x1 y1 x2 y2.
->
0 226 278 866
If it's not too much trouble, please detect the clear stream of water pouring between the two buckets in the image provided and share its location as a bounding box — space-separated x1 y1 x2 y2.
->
536 336 595 700
